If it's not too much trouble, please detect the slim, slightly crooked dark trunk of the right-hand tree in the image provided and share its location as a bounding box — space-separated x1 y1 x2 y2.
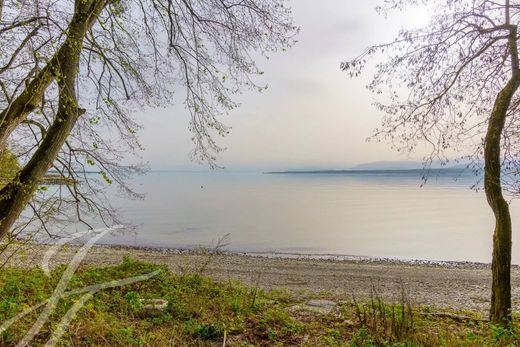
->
484 73 520 325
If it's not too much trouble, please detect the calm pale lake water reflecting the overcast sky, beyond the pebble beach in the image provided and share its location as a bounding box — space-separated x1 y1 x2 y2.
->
94 172 520 263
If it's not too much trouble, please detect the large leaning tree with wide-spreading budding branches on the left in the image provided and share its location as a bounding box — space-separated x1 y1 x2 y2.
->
0 0 297 239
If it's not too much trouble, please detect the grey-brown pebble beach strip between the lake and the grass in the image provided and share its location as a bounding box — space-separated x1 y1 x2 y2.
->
0 244 520 314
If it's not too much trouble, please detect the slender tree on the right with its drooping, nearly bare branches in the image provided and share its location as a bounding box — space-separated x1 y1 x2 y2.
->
341 0 520 324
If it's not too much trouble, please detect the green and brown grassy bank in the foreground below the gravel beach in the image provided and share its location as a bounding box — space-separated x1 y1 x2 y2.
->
0 259 520 347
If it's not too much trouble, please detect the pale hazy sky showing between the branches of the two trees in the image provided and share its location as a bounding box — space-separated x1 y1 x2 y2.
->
138 0 427 170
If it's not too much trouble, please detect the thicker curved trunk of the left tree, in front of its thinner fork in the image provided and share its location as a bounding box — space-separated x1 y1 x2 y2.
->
0 0 107 239
